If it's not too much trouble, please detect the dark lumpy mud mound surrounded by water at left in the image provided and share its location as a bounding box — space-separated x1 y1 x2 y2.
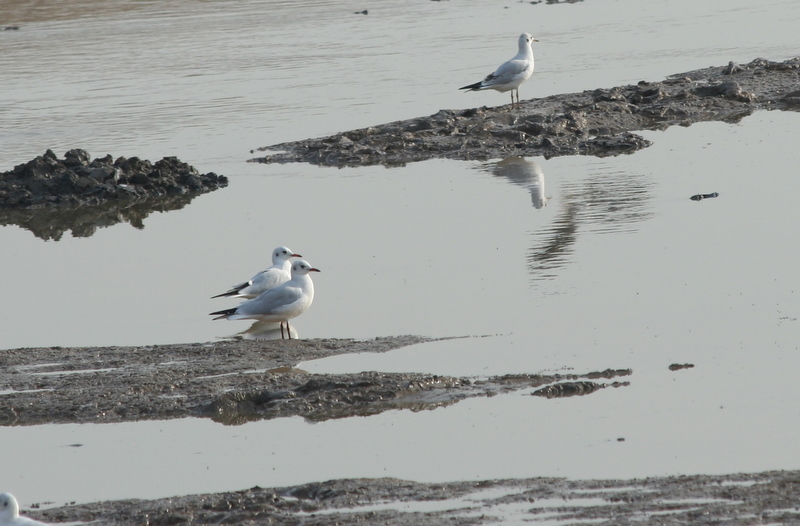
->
0 149 228 241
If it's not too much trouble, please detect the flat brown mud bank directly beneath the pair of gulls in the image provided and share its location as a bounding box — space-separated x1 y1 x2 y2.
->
0 336 632 425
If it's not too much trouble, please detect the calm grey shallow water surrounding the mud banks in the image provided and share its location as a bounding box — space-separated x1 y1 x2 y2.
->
0 0 800 505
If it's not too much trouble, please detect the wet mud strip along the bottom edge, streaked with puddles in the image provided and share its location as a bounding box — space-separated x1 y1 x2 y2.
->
29 471 800 526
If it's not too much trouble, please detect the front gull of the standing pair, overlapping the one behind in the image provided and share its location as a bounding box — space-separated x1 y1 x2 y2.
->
211 259 320 340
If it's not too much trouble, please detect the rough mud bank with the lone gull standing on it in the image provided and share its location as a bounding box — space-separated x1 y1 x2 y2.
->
250 57 800 166
